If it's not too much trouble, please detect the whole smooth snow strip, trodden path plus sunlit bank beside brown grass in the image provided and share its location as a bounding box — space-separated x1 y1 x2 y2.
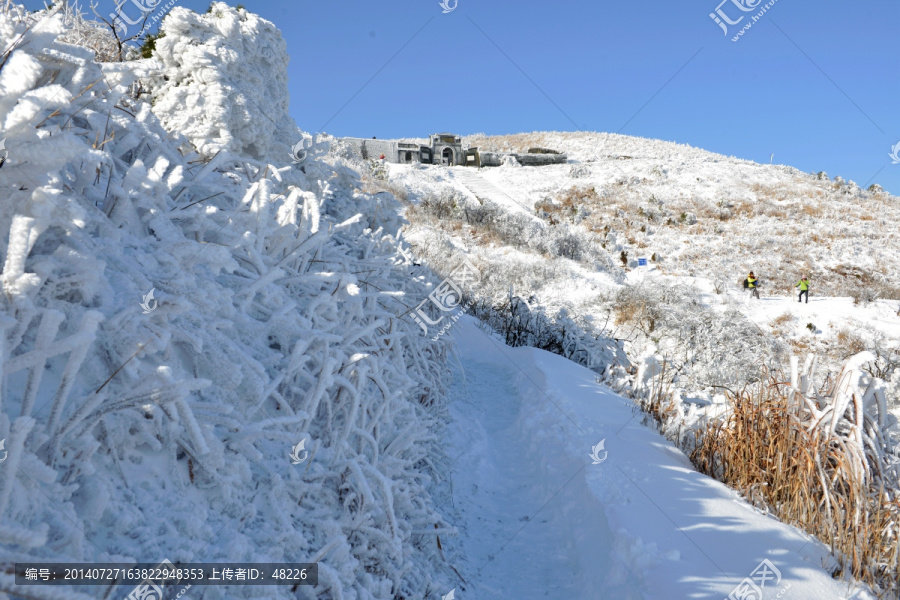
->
449 319 870 600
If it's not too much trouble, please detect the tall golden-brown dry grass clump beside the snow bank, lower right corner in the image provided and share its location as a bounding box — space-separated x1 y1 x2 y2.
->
690 377 900 591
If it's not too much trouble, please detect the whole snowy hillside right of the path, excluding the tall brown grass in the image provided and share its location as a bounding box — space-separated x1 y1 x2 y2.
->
357 129 900 586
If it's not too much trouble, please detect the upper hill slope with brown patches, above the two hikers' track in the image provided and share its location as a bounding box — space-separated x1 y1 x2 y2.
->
465 133 900 300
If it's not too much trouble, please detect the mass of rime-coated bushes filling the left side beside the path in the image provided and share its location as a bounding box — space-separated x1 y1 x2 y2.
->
0 4 449 600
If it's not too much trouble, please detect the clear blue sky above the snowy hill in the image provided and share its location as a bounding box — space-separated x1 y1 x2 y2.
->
45 0 900 195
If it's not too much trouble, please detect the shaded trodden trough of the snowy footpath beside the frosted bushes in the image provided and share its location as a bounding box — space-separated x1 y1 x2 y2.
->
453 331 624 600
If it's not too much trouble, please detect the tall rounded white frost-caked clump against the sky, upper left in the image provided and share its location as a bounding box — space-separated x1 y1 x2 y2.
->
153 2 297 159
